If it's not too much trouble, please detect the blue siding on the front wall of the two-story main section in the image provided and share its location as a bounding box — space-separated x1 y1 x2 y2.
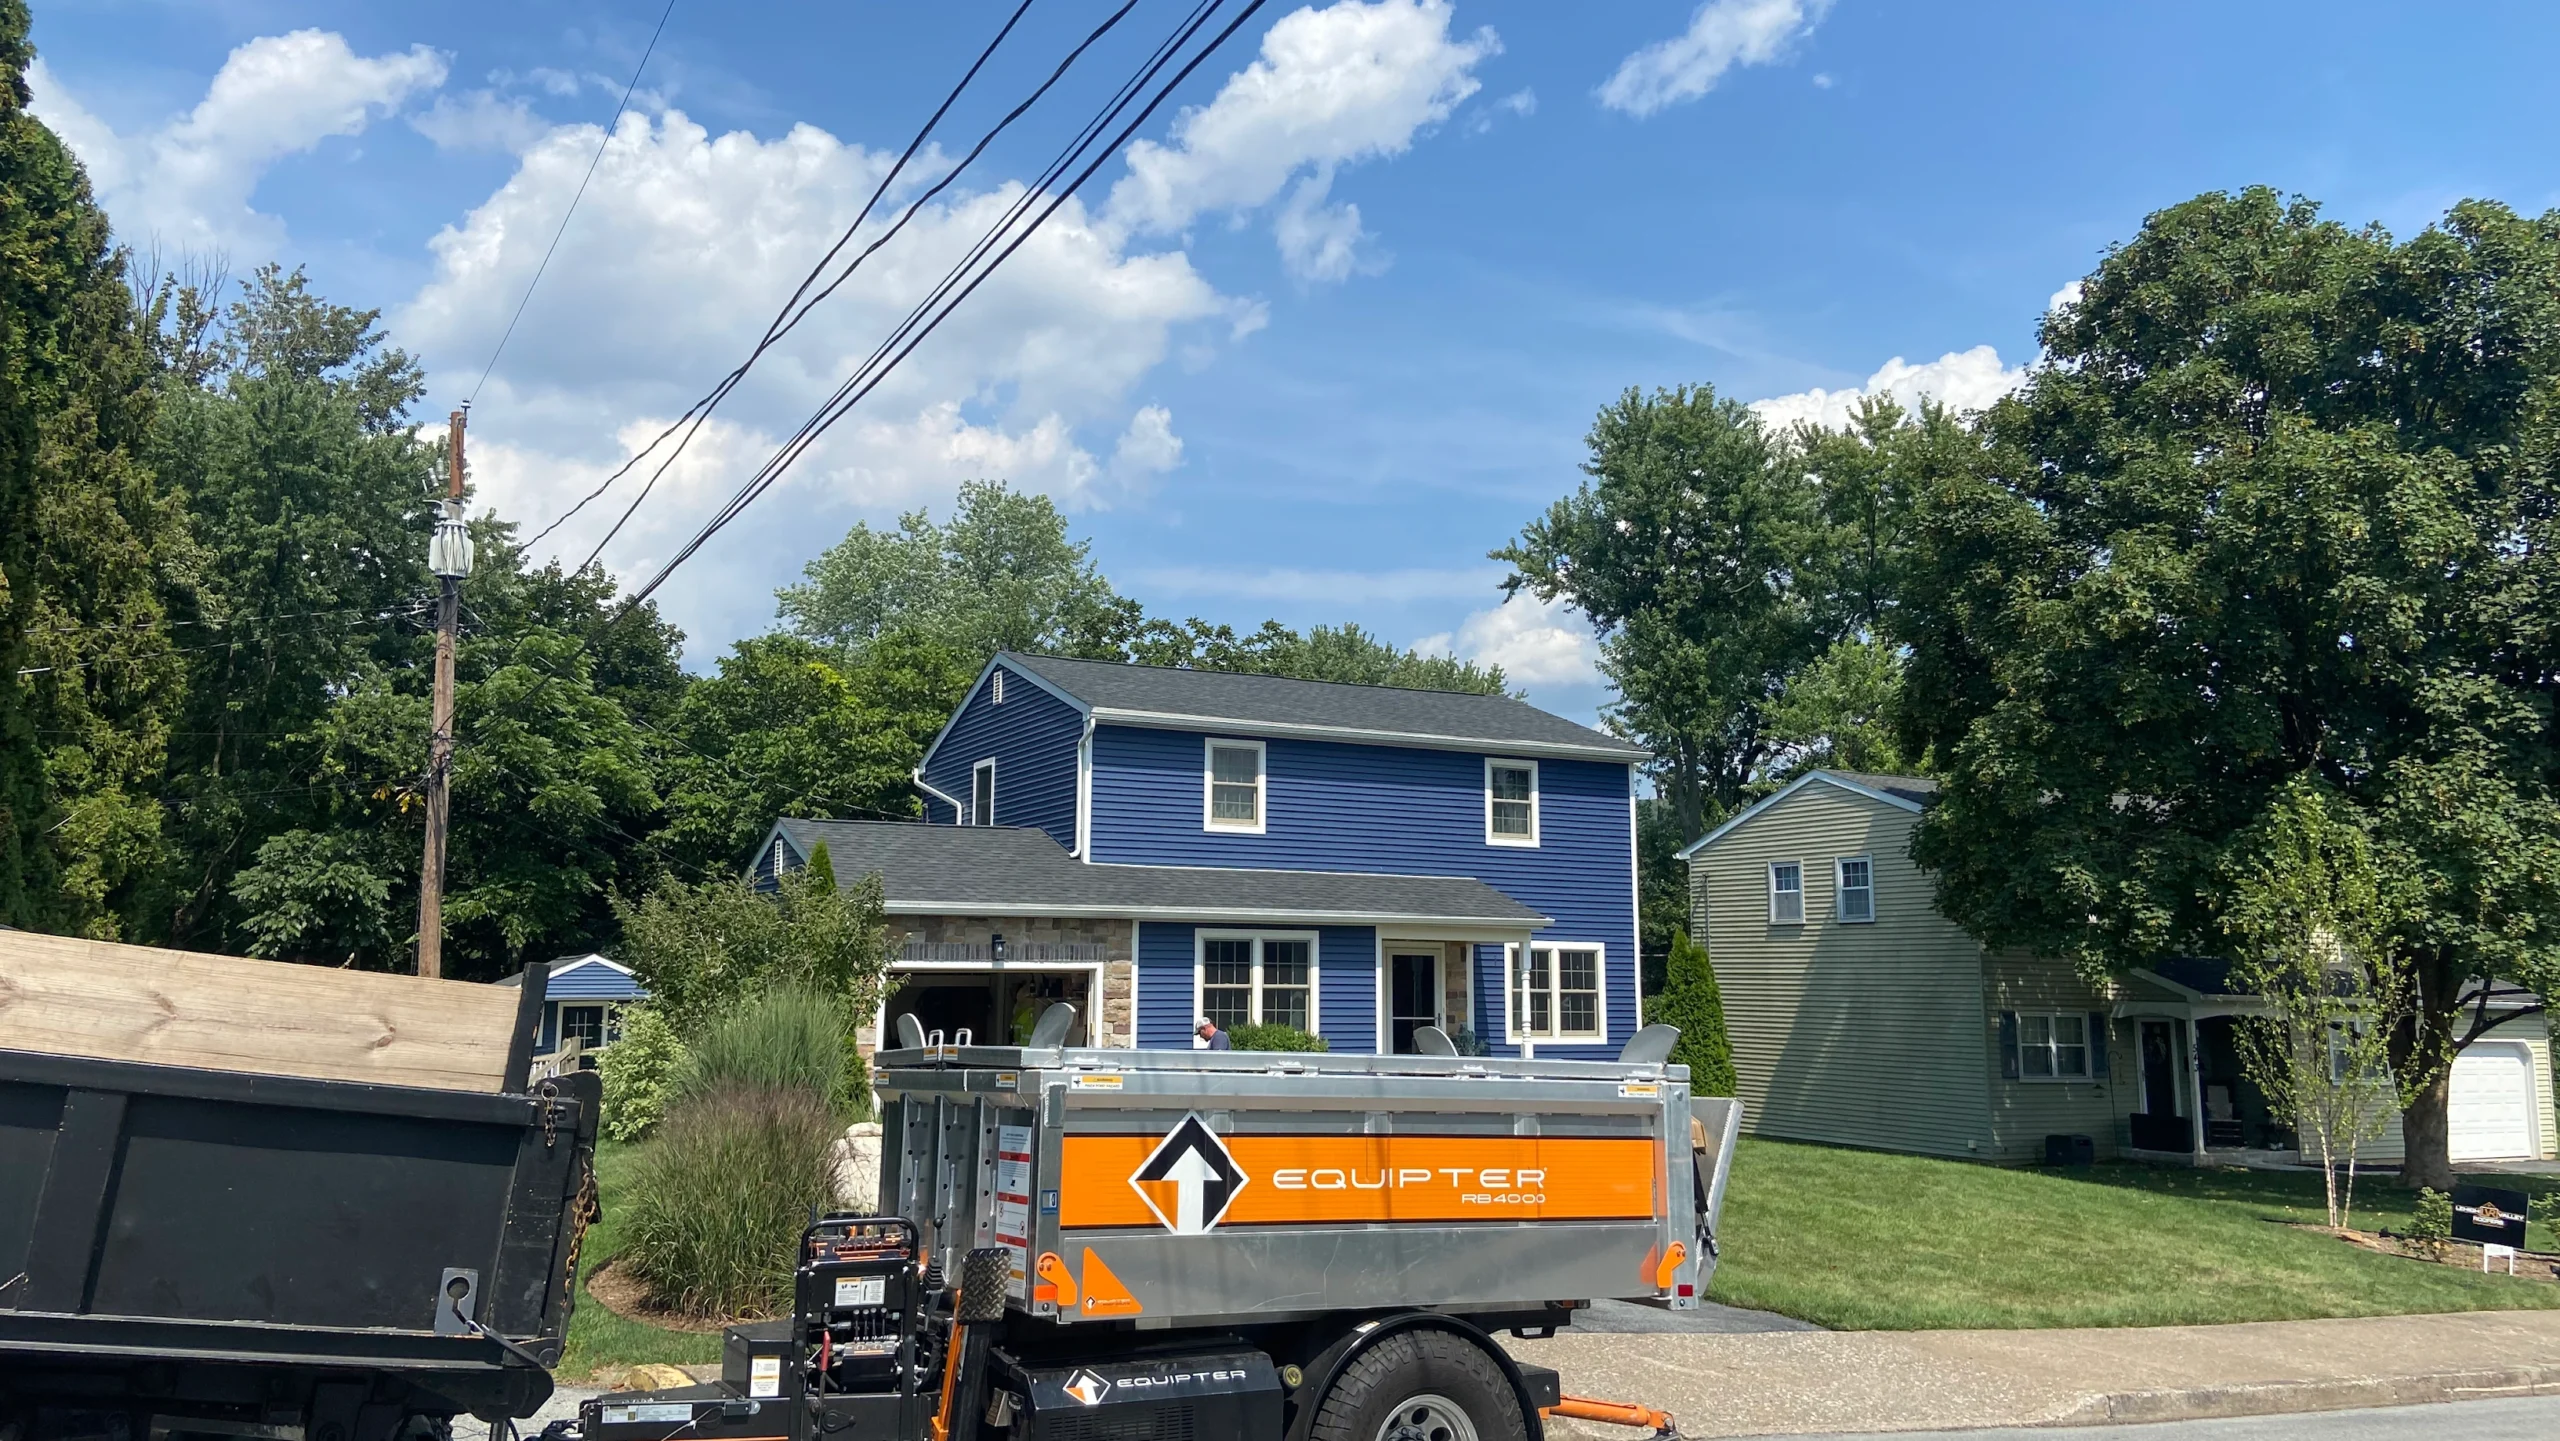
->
1090 724 1638 1060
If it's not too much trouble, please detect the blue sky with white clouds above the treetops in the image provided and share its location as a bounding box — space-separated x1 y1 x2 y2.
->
20 0 2560 714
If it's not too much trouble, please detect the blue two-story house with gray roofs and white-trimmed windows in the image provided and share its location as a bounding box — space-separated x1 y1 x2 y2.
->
755 653 1644 1057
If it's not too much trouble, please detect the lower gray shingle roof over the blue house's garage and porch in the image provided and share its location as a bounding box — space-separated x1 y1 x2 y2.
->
778 819 1549 929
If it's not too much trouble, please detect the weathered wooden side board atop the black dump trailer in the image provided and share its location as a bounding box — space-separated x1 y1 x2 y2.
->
0 932 520 1090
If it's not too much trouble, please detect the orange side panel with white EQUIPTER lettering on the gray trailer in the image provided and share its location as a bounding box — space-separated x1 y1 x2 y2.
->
1057 1136 1659 1228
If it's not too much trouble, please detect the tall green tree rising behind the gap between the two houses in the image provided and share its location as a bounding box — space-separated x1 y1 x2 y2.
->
1492 386 1836 837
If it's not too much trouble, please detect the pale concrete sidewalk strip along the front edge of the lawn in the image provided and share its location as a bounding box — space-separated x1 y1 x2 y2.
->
1503 1310 2560 1441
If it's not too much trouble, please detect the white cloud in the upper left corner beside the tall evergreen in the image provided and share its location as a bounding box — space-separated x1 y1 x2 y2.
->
31 31 445 253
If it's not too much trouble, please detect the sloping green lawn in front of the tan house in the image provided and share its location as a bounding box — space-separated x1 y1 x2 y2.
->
1710 1139 2560 1331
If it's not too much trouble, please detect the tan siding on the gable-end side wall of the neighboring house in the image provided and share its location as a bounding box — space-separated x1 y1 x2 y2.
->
1690 781 1997 1157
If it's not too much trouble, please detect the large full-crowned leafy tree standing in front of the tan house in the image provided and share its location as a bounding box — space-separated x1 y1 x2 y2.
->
1892 189 2560 1185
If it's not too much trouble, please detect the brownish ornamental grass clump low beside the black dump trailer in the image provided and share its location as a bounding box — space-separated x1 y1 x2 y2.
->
622 1088 837 1316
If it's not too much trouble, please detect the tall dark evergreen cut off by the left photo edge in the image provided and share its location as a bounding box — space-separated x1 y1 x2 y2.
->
0 0 184 937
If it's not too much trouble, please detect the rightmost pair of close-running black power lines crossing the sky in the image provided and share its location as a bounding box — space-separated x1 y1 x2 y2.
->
607 0 1265 614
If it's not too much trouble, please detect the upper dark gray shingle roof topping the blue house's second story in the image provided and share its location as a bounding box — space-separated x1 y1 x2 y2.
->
998 650 1646 760
